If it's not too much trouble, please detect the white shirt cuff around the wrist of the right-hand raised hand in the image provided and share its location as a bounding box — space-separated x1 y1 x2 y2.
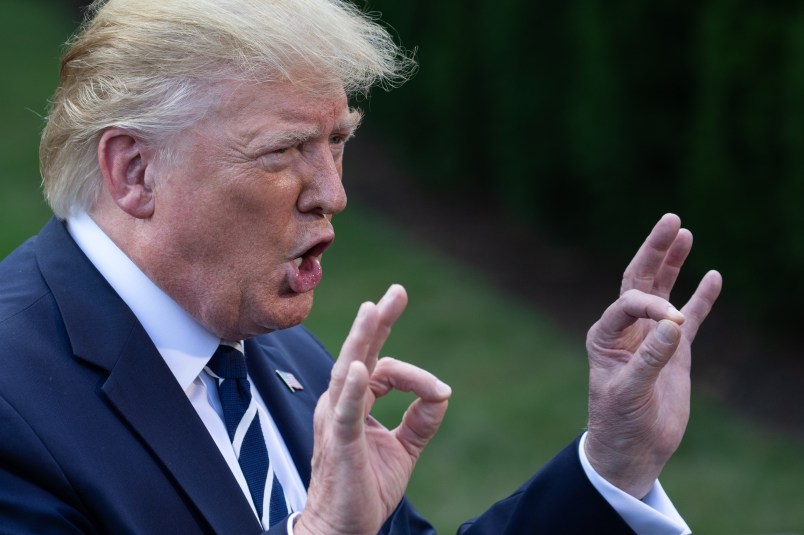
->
578 433 692 535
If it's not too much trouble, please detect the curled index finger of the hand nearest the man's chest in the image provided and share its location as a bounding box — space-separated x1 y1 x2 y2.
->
369 357 452 402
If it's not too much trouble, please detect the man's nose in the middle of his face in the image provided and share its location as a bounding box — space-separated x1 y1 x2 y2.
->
297 146 346 215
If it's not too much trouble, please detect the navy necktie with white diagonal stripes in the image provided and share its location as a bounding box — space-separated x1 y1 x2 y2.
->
207 344 288 527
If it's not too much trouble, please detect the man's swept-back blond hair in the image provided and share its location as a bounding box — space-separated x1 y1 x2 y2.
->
39 0 415 218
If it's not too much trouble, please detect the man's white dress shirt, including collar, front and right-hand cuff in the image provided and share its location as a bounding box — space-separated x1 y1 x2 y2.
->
67 212 691 535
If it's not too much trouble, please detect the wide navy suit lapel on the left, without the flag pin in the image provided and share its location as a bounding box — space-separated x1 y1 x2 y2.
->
37 220 262 534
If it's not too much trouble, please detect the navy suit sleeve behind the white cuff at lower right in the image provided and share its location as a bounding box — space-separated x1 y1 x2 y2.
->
458 438 634 535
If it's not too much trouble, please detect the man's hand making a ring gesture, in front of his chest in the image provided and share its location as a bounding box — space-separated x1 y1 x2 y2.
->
294 285 452 535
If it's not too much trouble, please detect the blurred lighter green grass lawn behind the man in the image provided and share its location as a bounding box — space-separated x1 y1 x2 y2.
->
0 0 804 534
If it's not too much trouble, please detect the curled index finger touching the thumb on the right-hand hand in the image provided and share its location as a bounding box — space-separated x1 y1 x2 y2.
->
590 290 684 347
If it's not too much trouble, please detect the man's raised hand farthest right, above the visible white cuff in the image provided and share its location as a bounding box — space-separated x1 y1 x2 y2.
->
585 214 722 499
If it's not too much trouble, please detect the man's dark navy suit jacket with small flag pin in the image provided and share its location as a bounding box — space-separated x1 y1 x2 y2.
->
0 219 631 535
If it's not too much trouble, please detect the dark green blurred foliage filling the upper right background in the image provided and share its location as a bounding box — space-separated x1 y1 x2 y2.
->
368 0 804 327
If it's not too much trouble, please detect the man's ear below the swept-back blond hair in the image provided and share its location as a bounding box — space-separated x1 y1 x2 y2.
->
98 128 155 219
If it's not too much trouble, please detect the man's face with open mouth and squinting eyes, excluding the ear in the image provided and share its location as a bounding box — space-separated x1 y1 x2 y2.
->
141 79 359 339
